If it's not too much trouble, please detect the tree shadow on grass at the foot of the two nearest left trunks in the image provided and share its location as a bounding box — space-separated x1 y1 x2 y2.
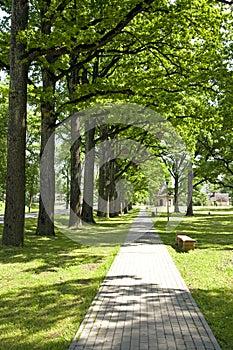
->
0 219 116 273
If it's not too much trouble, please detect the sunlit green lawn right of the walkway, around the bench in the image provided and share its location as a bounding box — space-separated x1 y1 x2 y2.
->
154 208 233 350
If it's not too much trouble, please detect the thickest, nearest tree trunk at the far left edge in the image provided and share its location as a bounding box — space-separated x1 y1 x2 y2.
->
2 0 28 246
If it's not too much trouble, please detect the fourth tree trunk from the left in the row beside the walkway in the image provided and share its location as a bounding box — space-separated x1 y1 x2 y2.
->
82 121 95 223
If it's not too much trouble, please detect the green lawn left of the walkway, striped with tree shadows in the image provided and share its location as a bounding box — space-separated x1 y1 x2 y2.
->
0 209 138 350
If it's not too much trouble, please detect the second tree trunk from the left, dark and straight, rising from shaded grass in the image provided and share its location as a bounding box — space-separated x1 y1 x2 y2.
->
36 7 56 236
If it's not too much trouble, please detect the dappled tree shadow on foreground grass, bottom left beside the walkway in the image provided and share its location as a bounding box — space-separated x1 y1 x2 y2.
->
0 278 101 350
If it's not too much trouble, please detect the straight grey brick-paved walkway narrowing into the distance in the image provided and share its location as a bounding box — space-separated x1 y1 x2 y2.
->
69 211 220 350
